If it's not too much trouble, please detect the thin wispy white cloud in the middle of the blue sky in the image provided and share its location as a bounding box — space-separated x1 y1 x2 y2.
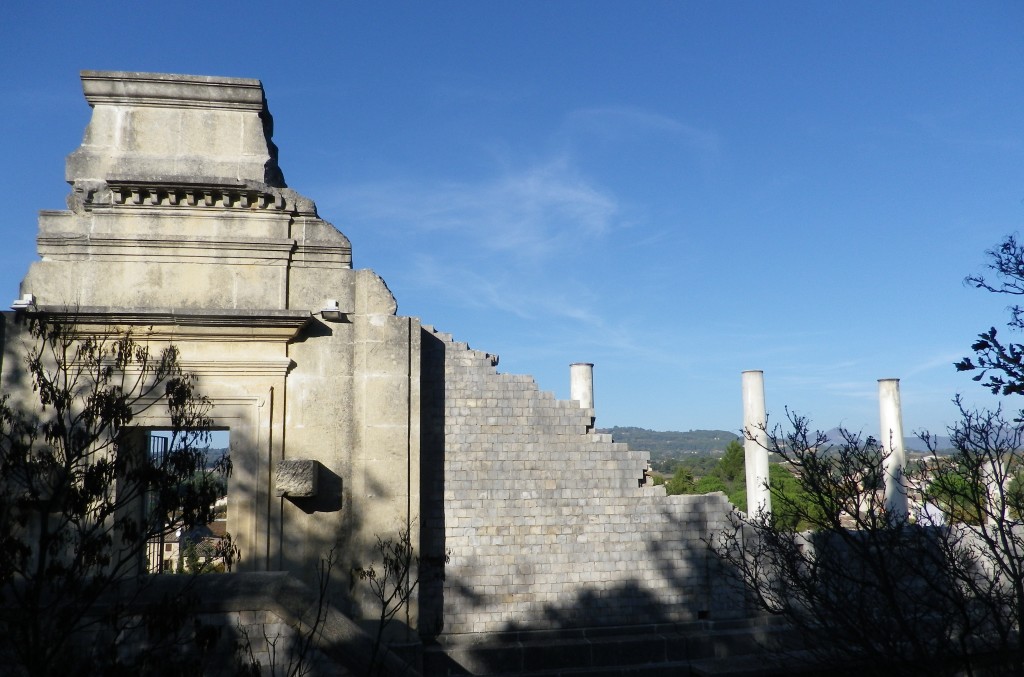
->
319 108 719 366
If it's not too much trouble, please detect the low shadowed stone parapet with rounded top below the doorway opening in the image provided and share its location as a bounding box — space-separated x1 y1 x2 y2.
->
9 572 405 677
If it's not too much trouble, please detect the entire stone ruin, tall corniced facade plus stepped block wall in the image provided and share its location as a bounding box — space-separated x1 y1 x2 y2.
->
3 71 749 661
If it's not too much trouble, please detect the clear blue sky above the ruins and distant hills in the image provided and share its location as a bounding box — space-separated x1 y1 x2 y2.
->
0 0 1024 433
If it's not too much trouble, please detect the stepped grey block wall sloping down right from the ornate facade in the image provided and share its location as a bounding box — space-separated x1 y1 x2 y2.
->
421 328 742 634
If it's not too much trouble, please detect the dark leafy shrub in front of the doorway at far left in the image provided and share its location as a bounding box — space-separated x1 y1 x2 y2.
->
0 313 230 675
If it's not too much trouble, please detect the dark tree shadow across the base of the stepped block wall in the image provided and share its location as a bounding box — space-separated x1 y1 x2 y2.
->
424 496 774 675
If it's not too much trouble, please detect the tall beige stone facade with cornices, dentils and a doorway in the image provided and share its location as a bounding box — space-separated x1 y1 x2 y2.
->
6 71 420 617
